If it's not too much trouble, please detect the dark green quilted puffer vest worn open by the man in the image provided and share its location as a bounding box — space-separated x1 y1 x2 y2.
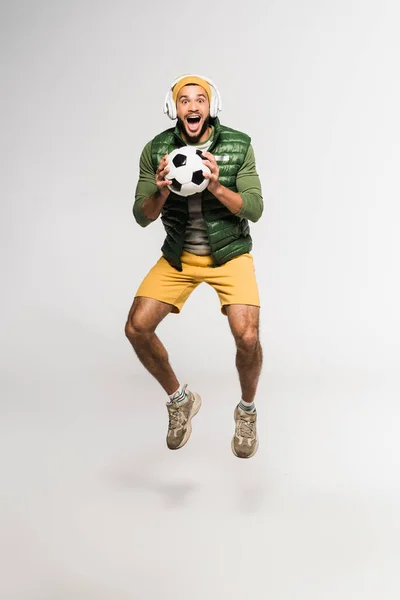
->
151 118 253 271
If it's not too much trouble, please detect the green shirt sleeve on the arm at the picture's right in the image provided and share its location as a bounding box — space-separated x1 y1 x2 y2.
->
236 144 264 223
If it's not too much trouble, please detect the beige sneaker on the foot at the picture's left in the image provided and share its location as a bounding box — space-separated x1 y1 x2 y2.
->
167 386 201 450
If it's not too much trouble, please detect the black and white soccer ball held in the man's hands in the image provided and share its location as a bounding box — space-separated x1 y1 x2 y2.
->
165 146 210 196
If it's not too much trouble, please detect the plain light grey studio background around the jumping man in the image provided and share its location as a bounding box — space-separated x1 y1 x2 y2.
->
0 0 400 600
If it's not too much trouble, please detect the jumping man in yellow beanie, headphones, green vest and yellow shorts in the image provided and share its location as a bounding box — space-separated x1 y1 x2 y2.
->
125 75 263 458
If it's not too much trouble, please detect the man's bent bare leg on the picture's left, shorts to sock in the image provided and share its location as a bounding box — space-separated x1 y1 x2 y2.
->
125 297 179 394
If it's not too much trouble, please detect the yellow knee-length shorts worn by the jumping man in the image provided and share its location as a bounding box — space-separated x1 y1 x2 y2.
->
135 251 260 315
